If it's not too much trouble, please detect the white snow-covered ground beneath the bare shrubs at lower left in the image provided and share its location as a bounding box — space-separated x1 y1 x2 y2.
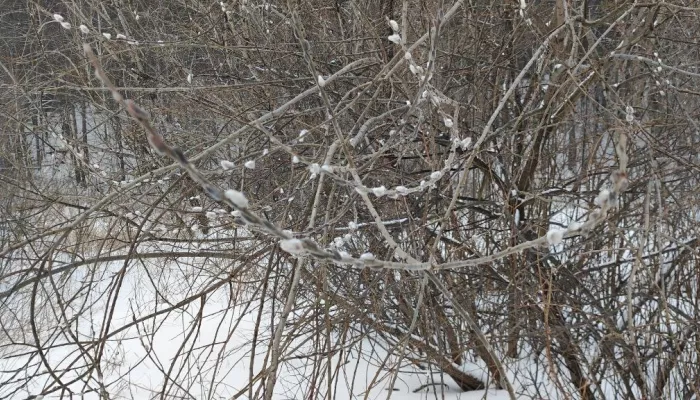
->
0 247 508 400
